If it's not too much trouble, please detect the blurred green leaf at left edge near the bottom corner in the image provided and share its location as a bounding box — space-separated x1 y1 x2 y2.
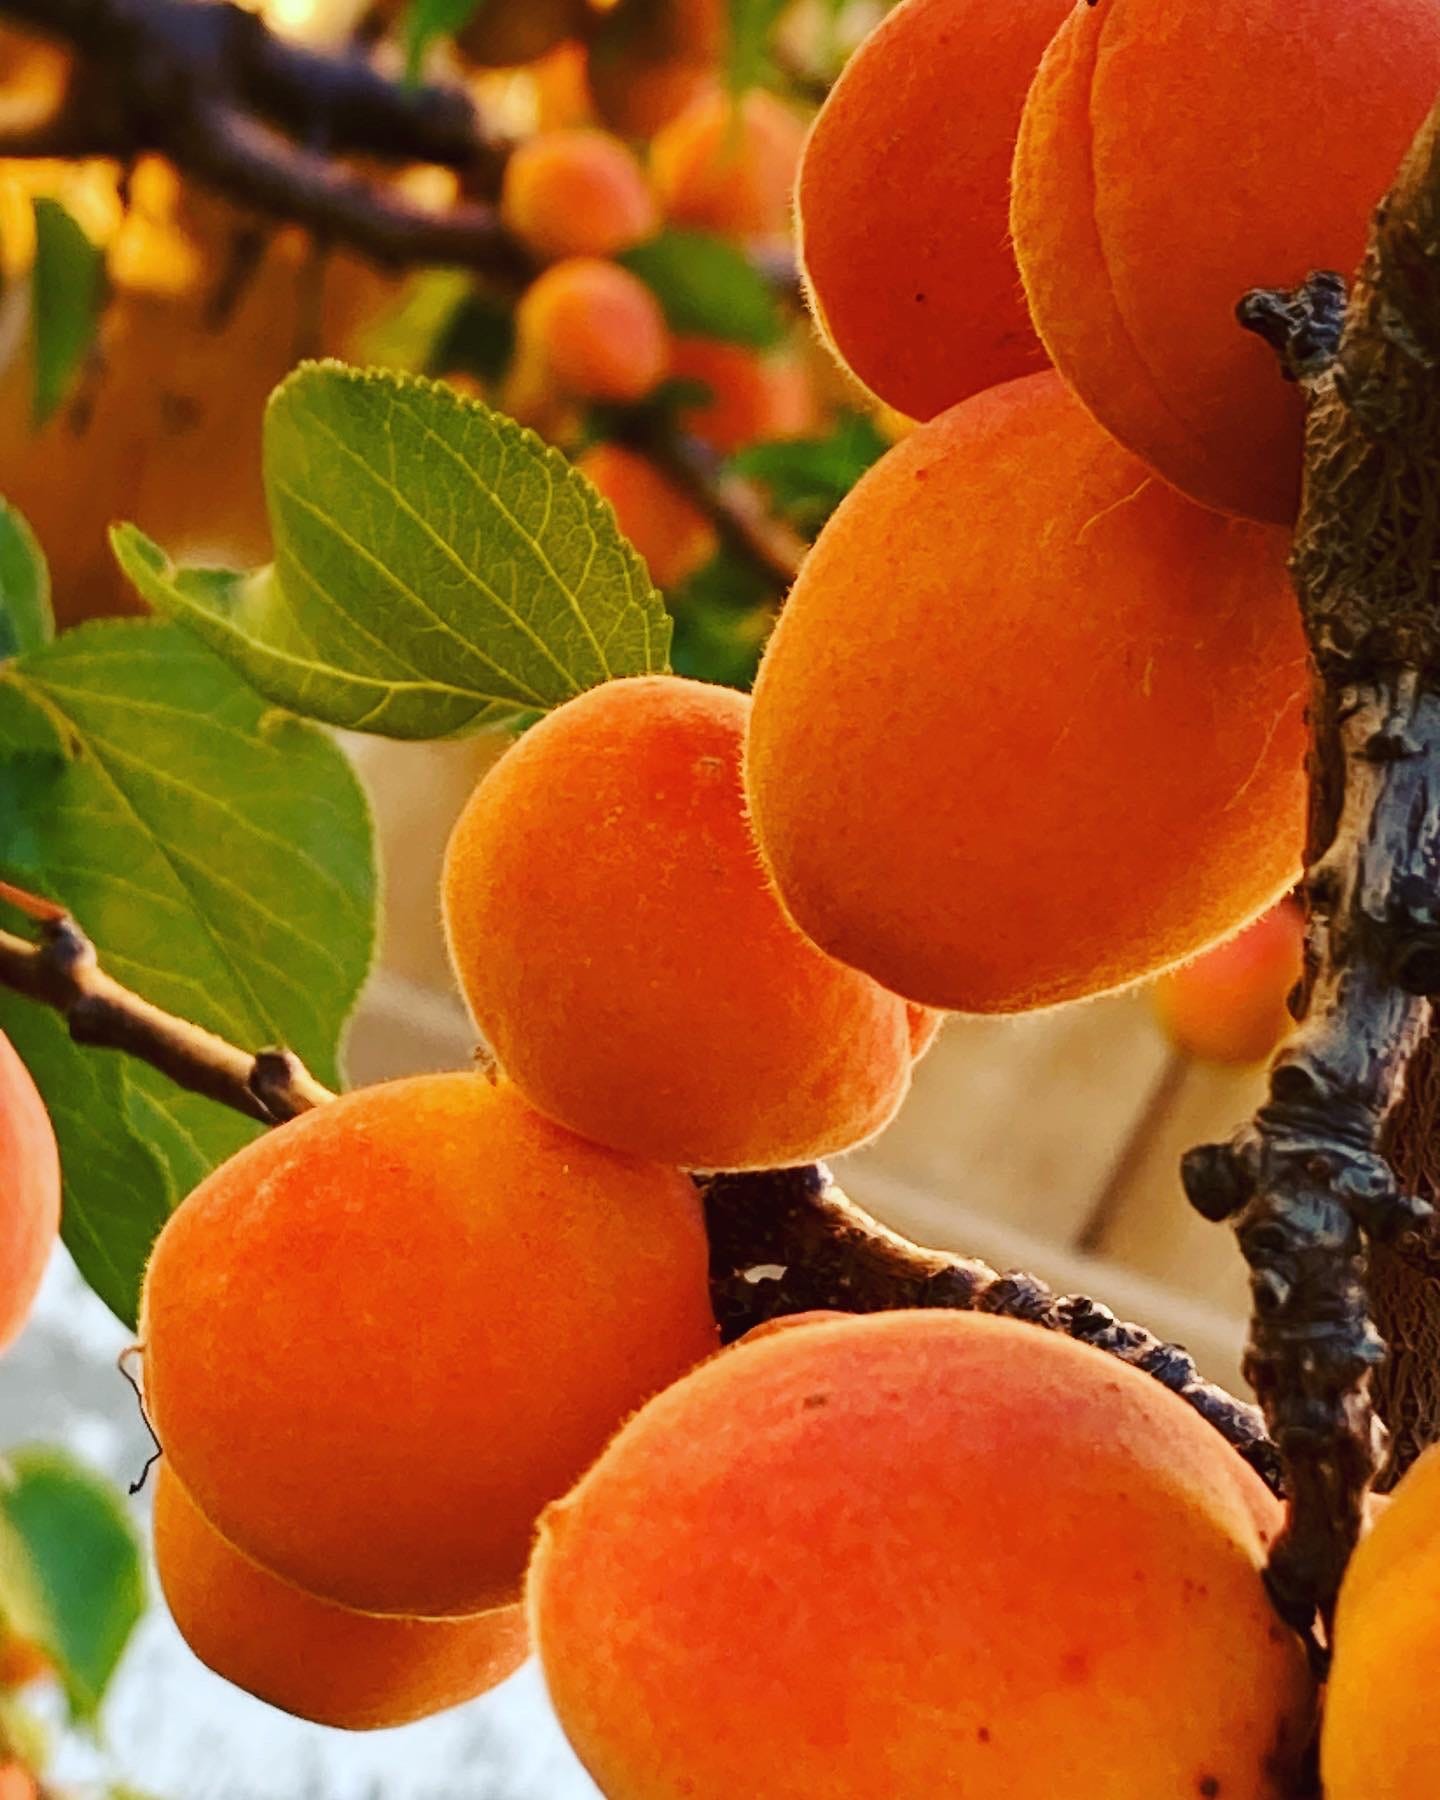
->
0 1449 146 1719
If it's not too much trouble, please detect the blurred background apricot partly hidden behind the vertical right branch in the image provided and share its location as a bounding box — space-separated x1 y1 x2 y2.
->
1150 902 1305 1062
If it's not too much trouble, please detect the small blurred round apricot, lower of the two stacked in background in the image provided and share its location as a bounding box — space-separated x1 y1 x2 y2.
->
515 256 670 401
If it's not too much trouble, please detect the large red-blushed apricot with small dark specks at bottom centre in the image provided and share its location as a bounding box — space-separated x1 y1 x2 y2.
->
527 1310 1312 1800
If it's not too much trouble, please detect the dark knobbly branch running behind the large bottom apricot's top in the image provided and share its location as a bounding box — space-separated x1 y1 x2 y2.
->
702 1166 1282 1494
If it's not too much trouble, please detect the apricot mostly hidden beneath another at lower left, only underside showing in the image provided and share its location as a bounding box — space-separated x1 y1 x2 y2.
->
155 1462 527 1732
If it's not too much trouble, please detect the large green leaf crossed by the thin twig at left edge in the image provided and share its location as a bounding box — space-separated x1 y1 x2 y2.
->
0 621 374 1325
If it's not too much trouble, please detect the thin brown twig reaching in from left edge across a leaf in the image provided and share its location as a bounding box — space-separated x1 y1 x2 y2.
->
0 884 333 1125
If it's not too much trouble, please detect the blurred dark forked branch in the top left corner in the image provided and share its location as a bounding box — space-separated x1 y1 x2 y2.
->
0 0 531 273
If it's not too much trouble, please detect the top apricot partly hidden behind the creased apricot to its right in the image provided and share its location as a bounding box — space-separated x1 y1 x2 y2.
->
796 0 1069 419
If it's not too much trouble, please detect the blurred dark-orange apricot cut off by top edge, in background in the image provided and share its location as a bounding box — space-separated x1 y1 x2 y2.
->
589 0 729 139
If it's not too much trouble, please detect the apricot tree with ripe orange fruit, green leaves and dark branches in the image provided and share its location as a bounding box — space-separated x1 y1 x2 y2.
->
0 0 1440 1800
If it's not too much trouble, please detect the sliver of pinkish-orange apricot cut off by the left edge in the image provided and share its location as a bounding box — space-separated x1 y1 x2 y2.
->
0 1031 59 1350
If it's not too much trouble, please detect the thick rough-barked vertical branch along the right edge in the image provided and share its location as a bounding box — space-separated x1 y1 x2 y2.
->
1184 91 1440 1629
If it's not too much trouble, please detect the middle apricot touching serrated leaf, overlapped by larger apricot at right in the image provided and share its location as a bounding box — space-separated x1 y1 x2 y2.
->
443 675 911 1168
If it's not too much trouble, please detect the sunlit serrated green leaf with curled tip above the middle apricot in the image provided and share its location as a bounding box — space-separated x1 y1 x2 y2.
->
112 362 670 738
